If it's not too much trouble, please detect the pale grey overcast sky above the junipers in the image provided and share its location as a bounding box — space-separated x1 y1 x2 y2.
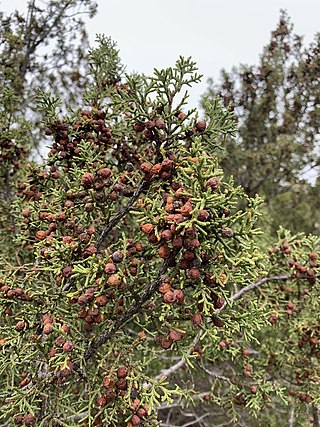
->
0 0 320 106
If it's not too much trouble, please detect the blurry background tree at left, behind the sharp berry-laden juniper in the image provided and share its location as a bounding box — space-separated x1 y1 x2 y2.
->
0 0 96 262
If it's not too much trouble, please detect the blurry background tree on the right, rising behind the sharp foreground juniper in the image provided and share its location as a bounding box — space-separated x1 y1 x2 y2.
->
203 12 320 236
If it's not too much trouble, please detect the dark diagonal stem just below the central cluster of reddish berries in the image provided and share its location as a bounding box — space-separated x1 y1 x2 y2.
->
84 249 179 360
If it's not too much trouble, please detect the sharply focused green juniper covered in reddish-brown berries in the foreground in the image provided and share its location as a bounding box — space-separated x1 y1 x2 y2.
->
0 37 320 427
